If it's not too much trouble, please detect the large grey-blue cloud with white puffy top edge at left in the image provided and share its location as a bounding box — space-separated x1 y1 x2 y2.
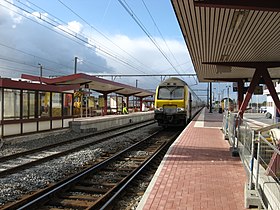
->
0 0 114 77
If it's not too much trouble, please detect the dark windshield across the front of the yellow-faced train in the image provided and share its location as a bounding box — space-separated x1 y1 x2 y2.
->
158 86 184 100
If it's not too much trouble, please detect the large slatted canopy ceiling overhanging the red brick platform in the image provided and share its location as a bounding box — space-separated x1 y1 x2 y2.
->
171 0 280 82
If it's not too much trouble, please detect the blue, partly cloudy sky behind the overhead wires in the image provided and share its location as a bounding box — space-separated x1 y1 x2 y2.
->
0 0 249 101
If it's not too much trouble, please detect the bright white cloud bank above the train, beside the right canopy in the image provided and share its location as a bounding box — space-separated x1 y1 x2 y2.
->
98 34 195 88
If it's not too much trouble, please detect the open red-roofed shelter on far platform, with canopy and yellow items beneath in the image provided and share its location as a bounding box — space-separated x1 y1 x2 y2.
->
22 73 154 117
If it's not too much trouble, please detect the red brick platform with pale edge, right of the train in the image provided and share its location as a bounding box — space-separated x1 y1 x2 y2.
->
137 109 246 210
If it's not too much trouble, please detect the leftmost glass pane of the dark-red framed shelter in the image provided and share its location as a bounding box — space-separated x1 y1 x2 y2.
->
3 89 20 120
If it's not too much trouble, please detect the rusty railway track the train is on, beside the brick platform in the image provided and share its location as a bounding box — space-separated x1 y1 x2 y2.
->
3 131 180 209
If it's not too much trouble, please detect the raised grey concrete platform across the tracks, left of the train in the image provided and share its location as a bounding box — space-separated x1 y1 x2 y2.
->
69 111 154 133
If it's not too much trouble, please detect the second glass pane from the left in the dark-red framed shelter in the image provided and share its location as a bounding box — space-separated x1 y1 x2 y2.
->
22 90 35 119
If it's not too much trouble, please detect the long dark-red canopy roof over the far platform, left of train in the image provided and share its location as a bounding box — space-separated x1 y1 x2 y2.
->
21 73 154 97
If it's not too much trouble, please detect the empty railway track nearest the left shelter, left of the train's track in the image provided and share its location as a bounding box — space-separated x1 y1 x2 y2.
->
0 122 154 177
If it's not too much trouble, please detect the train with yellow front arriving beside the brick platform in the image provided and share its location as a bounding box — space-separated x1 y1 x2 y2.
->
154 77 204 127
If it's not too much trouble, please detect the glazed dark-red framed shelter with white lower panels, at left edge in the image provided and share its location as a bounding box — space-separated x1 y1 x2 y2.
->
0 78 79 138
